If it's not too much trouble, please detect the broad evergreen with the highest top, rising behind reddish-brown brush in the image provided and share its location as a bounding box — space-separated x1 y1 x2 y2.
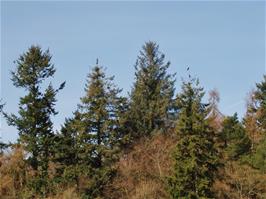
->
128 42 175 137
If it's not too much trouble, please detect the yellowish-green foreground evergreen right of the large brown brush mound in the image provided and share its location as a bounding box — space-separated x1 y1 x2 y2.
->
168 79 218 198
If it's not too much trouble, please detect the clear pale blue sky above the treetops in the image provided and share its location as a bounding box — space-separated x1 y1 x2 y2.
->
0 1 266 142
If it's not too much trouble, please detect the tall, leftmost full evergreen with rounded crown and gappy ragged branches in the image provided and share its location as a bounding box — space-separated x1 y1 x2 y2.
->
4 46 65 195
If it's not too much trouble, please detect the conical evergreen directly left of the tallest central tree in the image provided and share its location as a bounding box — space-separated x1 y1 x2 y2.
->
78 66 124 198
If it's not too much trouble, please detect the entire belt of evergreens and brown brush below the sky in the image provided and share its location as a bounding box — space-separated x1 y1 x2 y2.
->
0 42 266 199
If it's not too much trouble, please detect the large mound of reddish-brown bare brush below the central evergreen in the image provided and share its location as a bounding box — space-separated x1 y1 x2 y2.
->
105 133 176 199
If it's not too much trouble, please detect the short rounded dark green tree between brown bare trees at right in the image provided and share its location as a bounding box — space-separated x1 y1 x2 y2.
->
220 113 251 160
